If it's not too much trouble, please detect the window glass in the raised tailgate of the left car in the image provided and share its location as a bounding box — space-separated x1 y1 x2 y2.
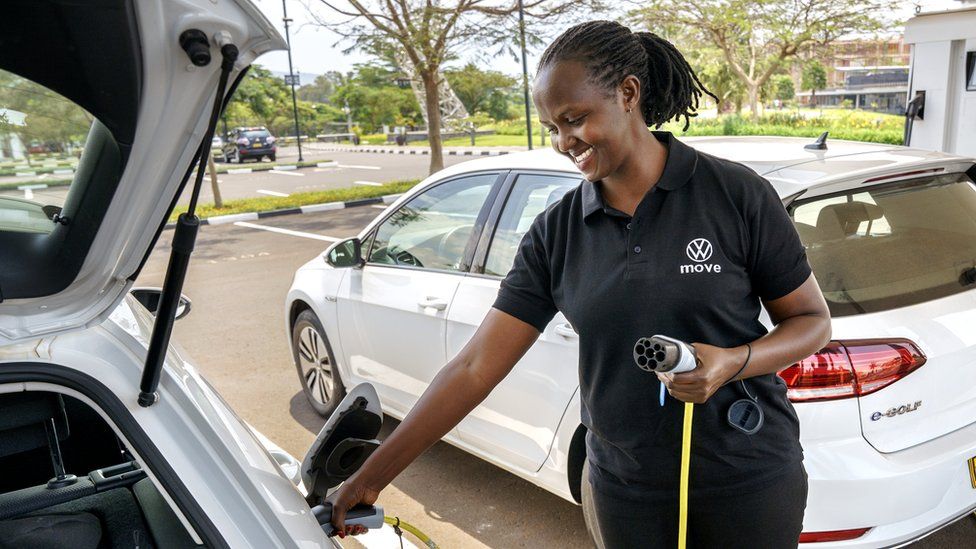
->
0 70 94 234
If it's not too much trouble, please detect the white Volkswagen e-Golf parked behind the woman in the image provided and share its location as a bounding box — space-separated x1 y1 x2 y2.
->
285 137 976 547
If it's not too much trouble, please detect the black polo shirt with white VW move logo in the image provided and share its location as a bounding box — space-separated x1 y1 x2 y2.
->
494 132 811 500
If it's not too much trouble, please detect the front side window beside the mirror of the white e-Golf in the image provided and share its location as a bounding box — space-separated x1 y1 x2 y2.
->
368 174 497 271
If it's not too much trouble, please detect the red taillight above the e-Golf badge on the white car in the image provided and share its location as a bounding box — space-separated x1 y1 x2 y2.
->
779 339 925 402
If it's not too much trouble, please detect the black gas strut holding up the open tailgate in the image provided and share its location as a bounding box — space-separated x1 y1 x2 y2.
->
139 29 239 408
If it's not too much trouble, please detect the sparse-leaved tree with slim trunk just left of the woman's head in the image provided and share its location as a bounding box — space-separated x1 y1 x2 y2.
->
312 0 599 173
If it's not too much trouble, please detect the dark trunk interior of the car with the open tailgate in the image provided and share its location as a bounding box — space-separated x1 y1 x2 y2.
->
0 391 197 549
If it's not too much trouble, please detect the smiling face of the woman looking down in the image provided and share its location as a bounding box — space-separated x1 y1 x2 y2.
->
533 61 640 181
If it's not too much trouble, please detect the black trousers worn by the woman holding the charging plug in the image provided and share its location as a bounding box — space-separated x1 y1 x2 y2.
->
593 463 807 549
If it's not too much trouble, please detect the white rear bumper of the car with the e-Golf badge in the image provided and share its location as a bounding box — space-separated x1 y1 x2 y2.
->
801 418 976 549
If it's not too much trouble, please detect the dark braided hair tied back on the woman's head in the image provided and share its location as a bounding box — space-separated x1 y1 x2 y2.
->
539 21 718 131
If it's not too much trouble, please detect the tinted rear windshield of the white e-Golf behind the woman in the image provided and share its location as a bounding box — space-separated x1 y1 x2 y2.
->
789 174 976 317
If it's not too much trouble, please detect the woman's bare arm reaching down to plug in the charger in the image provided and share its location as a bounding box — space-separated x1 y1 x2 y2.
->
329 309 539 534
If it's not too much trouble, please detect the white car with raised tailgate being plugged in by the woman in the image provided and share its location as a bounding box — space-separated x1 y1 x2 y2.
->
0 0 382 549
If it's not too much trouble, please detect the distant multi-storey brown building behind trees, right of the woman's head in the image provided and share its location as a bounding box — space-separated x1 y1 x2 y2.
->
792 35 911 114
